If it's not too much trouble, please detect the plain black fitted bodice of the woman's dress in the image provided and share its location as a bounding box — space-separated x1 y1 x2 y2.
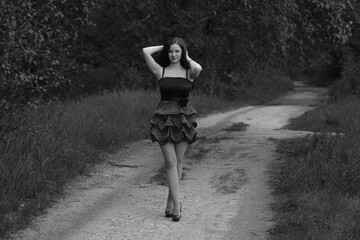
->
159 77 192 101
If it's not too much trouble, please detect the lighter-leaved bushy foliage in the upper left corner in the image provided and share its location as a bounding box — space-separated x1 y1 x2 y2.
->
0 0 93 109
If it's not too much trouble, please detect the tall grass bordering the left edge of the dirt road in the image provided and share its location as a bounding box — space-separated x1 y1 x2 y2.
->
0 70 289 237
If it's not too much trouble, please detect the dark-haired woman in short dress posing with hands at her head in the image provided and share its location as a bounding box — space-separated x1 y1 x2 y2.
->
142 38 202 222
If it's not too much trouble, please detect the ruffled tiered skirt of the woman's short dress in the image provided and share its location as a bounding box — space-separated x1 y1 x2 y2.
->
150 101 197 145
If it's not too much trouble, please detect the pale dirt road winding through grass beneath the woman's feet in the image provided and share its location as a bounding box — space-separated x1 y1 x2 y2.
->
14 84 326 240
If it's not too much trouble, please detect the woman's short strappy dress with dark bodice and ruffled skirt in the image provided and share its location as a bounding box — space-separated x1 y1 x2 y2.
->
150 69 197 145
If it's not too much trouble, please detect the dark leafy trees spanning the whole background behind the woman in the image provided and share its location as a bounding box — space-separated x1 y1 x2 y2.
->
0 0 359 109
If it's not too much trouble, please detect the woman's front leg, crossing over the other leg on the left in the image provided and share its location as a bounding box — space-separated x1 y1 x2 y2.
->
160 143 180 214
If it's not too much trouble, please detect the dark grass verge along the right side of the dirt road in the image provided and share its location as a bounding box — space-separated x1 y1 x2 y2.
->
270 98 360 240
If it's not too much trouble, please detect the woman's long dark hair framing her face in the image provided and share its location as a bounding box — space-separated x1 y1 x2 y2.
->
155 37 190 69
